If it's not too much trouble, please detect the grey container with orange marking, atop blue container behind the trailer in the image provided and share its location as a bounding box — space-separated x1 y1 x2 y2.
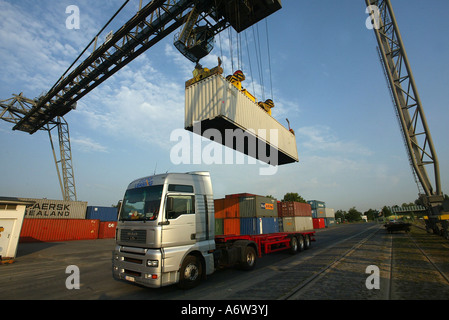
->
240 196 278 218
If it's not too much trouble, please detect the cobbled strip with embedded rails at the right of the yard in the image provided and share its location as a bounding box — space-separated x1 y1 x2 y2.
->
279 222 449 300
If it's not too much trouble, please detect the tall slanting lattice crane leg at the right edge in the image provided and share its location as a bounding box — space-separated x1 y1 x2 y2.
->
365 0 449 238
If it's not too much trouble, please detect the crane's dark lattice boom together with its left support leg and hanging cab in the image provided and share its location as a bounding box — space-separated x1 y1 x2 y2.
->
0 0 281 200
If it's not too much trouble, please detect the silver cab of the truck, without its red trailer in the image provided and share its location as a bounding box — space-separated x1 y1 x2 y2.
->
113 172 215 287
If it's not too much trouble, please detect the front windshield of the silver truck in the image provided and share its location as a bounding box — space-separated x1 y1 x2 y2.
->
120 185 163 221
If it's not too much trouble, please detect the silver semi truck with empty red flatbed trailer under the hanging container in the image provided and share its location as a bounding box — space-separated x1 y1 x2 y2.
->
112 172 315 289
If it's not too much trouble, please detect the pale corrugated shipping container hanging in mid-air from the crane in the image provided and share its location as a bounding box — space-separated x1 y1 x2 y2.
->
185 74 298 165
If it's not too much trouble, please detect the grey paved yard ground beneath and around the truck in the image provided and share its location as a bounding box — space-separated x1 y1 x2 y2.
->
0 224 449 301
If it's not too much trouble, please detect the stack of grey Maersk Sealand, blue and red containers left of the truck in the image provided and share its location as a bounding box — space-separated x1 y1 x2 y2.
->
19 198 117 243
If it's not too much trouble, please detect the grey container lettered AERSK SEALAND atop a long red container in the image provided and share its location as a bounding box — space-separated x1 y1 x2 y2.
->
19 198 87 219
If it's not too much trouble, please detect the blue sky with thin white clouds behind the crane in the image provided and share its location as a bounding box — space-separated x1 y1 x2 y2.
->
0 0 449 212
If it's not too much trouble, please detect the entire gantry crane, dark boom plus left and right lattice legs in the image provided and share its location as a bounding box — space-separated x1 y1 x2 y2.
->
0 0 448 236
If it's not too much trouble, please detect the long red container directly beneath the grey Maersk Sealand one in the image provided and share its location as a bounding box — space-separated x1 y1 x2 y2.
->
19 219 100 242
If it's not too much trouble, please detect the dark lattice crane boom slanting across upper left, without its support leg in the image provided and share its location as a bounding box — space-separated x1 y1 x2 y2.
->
9 0 280 134
